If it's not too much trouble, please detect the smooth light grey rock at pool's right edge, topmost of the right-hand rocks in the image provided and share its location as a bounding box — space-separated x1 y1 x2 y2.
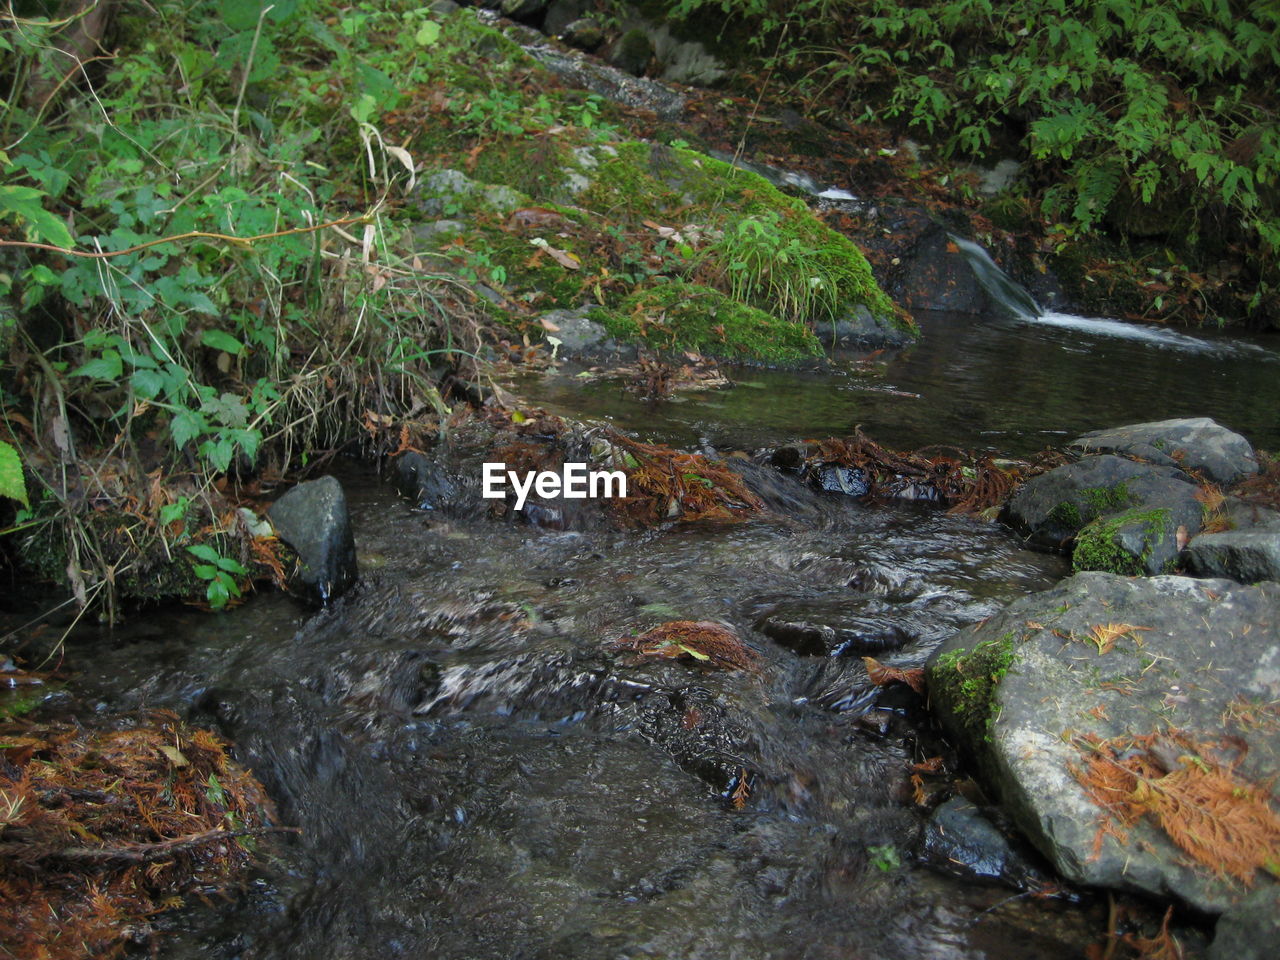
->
1070 417 1258 485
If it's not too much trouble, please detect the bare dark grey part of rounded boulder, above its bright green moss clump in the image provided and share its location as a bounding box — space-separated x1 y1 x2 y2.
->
1002 454 1202 549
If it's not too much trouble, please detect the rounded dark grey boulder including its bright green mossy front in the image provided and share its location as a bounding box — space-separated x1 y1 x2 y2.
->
1004 454 1203 573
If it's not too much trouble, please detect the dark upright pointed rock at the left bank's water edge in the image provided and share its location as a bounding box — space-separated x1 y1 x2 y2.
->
266 476 358 603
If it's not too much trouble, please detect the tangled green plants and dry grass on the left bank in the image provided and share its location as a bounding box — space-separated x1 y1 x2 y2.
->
0 0 483 607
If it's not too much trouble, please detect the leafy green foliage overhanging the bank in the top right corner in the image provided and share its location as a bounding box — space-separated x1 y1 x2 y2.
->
671 0 1280 320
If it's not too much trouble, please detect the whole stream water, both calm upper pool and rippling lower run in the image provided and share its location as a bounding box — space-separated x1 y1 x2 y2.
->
42 296 1280 960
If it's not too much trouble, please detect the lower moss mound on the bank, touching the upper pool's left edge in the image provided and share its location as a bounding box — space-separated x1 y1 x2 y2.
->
593 282 822 364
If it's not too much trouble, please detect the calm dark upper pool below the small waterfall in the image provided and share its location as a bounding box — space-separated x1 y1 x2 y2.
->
520 314 1280 456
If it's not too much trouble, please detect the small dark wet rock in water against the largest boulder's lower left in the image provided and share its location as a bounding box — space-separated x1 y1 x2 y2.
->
920 796 1041 888
